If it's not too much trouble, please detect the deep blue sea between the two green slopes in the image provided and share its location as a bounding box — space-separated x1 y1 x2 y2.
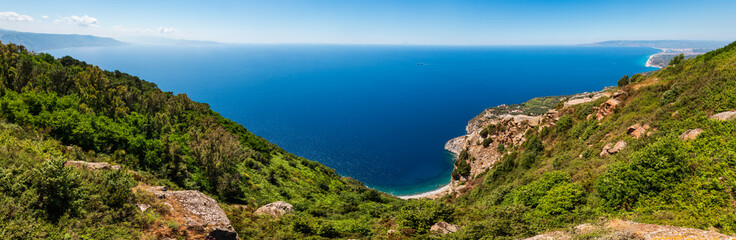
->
49 45 658 195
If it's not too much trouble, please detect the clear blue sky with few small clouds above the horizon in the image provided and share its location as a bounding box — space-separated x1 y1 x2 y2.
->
0 0 736 45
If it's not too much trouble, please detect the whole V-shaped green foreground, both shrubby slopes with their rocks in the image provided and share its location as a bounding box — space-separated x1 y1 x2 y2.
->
0 39 736 239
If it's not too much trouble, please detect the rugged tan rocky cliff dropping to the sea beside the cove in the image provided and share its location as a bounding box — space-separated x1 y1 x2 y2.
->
445 88 626 194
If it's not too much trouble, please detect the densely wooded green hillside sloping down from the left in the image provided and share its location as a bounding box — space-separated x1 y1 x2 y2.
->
0 41 402 239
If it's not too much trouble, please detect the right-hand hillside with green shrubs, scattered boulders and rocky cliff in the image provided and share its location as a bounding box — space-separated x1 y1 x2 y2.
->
448 40 736 239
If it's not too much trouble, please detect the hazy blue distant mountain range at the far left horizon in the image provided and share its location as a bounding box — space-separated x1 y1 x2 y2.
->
0 29 127 51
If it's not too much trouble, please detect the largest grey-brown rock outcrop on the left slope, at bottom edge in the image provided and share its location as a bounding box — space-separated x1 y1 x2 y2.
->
146 187 237 238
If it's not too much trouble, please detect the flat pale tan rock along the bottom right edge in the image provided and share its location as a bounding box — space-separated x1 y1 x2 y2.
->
526 220 736 240
